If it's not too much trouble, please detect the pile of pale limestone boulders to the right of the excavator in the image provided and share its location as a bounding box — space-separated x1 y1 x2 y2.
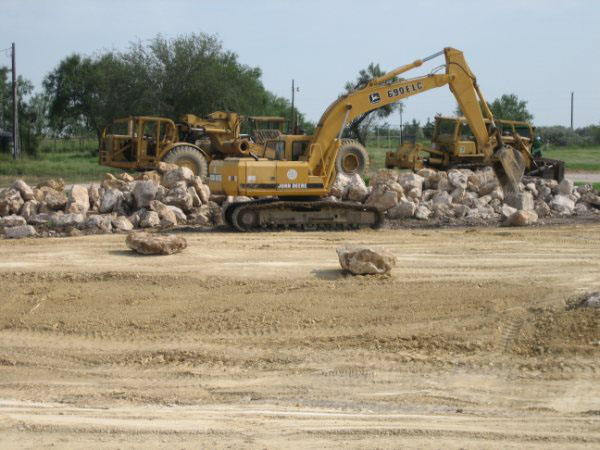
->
331 168 600 226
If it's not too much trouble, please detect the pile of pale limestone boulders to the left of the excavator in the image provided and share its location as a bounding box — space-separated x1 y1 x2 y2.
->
0 163 222 238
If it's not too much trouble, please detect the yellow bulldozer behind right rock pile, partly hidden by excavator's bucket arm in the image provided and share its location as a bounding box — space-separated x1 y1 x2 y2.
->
385 116 565 181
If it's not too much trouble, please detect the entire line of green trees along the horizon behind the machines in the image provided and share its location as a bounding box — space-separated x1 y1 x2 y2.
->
0 33 600 154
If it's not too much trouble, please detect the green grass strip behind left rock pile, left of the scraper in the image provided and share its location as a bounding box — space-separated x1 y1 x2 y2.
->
0 151 121 186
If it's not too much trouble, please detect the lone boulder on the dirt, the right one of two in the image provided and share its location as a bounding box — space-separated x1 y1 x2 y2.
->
337 247 396 275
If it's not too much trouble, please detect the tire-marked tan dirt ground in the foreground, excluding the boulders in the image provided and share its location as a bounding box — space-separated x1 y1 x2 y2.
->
0 223 600 449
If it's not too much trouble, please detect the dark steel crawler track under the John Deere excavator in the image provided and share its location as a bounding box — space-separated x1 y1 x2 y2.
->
224 199 383 231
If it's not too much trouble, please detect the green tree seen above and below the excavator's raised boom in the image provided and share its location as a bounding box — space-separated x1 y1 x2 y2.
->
345 63 401 145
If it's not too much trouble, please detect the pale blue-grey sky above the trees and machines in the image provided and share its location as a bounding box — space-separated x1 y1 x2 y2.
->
0 0 600 127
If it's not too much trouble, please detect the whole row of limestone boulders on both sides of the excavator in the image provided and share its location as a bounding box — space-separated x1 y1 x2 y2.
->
0 163 600 238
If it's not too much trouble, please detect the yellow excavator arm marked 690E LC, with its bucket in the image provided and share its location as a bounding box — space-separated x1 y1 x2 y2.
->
308 47 524 191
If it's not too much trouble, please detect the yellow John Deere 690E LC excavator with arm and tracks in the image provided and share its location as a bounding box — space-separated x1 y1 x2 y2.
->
209 47 531 231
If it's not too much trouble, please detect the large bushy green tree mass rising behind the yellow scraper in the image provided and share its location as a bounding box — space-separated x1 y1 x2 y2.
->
44 34 303 146
